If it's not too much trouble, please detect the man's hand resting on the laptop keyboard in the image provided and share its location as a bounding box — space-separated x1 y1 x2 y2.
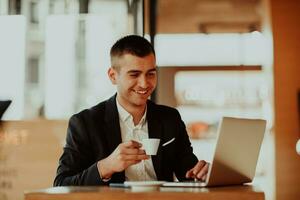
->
185 160 209 181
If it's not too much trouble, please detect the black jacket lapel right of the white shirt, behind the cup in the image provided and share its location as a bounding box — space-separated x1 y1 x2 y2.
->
147 101 163 180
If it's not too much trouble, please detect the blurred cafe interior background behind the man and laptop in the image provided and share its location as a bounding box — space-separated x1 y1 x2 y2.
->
0 0 300 200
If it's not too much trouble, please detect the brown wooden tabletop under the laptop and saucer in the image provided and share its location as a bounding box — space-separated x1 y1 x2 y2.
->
24 186 265 200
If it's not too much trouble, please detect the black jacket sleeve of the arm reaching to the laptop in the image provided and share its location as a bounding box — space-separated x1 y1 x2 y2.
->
175 111 198 181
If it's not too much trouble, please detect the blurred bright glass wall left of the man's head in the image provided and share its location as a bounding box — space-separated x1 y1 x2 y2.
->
0 0 143 120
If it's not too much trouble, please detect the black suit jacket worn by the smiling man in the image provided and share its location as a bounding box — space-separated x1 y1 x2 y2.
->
54 95 198 186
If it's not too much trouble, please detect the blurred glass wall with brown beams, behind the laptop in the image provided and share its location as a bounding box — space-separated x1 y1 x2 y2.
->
155 0 275 199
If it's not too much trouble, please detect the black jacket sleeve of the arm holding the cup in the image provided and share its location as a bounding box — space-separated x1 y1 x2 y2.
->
53 114 107 186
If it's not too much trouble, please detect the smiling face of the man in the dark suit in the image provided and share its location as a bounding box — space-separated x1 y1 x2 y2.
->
108 54 157 108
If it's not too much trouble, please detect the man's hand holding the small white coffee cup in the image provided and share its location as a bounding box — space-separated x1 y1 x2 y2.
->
97 140 149 179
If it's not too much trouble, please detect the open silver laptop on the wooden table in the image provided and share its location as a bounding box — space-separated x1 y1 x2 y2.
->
163 117 266 187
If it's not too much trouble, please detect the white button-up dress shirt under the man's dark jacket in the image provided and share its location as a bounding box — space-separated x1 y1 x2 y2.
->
116 100 157 181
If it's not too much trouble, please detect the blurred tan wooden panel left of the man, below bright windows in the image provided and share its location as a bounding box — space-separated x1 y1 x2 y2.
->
0 119 68 200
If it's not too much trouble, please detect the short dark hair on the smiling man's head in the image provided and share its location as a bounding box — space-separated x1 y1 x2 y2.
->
110 35 155 64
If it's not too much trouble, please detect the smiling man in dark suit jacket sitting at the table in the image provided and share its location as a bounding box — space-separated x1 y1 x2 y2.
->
54 35 208 186
